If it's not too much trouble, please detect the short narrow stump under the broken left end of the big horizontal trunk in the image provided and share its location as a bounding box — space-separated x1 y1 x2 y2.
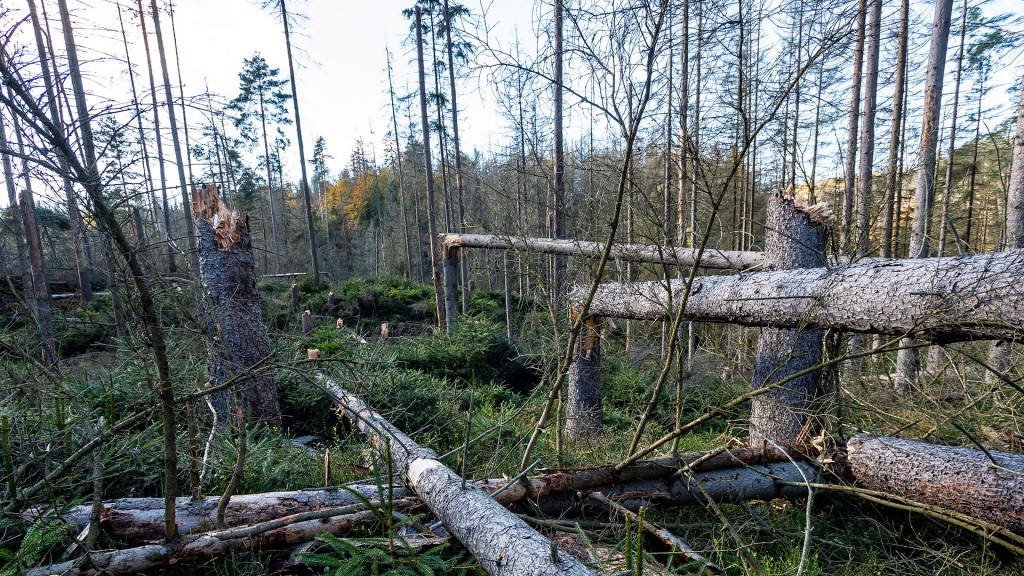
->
564 316 604 434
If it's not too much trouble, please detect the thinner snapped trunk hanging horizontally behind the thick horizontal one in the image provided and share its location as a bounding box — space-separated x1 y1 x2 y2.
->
441 234 764 270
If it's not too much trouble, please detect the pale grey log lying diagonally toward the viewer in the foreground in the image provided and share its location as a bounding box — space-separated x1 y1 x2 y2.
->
319 376 594 576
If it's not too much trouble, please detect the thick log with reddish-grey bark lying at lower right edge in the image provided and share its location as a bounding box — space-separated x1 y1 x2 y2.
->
847 435 1024 532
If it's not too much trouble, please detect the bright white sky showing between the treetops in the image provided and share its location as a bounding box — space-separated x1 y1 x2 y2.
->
0 0 1024 208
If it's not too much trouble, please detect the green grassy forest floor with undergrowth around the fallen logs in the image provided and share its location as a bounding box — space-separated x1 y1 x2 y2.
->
0 277 1024 575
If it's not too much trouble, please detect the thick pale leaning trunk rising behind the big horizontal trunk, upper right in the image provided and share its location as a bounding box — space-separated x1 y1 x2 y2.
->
896 0 952 394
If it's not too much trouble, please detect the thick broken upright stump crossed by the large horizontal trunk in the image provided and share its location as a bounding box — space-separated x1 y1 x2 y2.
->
750 194 827 446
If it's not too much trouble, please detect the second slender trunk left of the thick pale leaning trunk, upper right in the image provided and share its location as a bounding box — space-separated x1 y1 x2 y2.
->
856 0 882 256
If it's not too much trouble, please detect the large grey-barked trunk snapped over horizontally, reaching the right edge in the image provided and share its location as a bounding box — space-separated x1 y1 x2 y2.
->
569 249 1024 343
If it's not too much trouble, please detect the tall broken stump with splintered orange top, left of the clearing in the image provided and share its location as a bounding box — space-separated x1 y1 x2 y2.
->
193 186 281 426
